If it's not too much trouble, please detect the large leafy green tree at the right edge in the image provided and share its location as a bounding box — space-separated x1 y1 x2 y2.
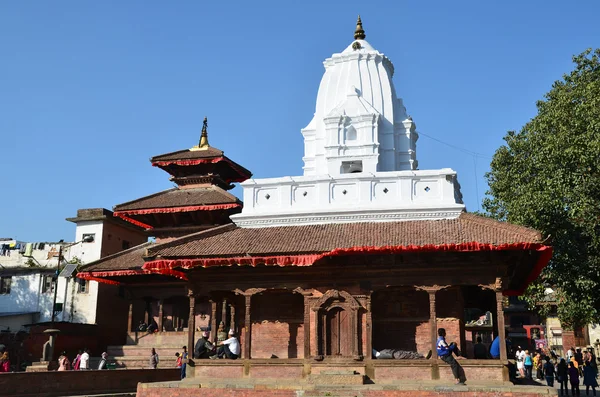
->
483 49 600 329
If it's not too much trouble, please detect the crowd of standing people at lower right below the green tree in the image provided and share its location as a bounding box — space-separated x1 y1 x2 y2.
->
515 346 598 396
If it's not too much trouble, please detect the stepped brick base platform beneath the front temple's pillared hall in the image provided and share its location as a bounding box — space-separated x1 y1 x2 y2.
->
137 359 557 397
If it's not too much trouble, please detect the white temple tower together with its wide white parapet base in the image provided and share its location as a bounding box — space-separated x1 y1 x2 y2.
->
231 17 465 227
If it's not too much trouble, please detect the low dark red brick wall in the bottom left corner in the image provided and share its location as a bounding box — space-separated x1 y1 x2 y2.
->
0 368 181 397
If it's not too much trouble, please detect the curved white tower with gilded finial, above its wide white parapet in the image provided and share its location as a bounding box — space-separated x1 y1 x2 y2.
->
302 17 418 175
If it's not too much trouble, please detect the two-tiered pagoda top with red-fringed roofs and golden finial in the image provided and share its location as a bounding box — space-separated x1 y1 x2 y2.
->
114 118 252 241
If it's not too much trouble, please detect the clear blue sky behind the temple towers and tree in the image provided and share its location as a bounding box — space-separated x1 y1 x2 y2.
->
0 0 600 241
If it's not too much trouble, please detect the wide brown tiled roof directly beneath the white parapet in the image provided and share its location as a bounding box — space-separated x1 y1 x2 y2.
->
149 213 541 258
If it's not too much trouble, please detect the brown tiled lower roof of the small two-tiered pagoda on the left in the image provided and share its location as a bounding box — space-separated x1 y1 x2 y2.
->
113 185 241 211
